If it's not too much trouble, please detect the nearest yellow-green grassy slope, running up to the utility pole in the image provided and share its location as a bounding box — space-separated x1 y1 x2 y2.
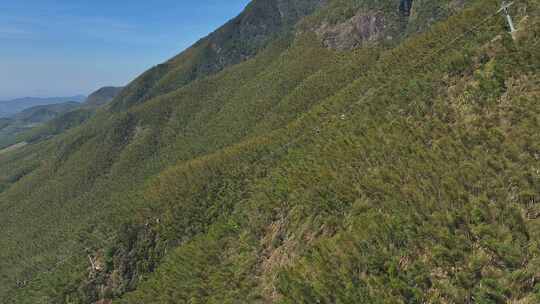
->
119 1 540 303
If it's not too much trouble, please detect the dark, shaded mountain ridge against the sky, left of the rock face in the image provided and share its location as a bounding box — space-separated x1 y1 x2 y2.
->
113 0 326 109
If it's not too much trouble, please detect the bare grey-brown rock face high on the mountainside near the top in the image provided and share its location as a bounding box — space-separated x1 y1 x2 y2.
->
315 11 386 50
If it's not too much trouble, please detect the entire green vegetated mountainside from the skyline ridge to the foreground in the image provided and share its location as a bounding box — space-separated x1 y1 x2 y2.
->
0 0 540 303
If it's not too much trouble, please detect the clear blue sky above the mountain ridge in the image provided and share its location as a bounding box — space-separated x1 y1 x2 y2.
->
0 0 249 100
